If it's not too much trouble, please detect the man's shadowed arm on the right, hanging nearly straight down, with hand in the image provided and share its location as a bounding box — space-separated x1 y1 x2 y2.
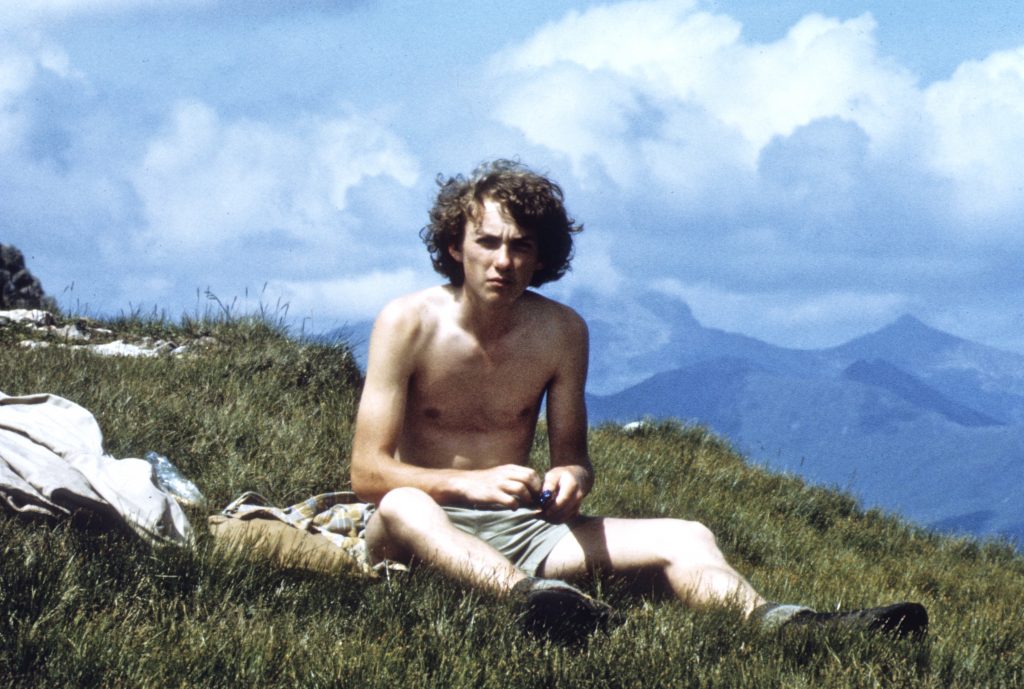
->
543 311 594 521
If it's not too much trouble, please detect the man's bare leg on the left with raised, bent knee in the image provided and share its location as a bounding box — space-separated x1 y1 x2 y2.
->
367 487 526 595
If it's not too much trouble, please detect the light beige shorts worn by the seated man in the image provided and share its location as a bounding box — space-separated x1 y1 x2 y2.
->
441 506 580 576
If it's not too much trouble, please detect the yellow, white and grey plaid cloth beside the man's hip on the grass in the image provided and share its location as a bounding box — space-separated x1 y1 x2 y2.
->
221 490 404 575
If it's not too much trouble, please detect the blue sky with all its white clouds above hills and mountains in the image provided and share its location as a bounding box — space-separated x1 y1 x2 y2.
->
0 0 1024 370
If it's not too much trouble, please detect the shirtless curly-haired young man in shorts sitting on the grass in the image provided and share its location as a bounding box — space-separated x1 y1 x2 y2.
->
351 161 927 629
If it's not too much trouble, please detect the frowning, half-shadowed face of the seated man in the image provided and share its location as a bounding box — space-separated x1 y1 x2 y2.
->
451 194 541 300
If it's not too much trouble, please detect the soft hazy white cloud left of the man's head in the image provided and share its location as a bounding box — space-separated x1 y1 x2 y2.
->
133 101 419 252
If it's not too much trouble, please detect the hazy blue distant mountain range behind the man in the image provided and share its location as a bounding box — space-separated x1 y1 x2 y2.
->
324 293 1024 544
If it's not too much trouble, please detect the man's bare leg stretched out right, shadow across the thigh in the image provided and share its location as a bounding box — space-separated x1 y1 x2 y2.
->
541 518 766 614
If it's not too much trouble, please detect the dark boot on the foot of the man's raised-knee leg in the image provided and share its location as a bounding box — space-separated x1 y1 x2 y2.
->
512 577 613 642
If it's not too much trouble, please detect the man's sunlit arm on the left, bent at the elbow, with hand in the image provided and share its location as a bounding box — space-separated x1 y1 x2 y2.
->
351 302 541 508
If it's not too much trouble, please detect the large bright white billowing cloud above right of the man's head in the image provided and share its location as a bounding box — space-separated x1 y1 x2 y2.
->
493 0 918 189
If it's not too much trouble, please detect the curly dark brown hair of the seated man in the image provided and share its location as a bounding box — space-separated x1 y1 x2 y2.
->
420 160 583 287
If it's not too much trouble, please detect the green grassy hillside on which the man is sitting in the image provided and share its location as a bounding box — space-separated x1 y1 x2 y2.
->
0 319 1024 689
